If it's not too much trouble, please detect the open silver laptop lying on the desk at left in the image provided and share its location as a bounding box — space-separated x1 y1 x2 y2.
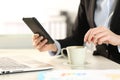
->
0 57 53 75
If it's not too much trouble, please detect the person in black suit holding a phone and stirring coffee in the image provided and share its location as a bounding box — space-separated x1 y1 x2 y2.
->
33 0 120 63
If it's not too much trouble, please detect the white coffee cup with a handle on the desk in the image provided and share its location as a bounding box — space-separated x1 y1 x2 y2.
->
61 46 86 66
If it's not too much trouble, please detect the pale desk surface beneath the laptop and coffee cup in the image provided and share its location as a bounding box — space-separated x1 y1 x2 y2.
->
0 49 120 80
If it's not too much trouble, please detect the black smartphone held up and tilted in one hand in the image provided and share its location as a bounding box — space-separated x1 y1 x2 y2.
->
23 17 54 44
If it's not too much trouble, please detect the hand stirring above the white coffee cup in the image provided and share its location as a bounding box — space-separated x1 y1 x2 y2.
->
84 27 120 45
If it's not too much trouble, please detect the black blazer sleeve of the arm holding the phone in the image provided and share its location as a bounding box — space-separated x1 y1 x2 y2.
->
57 0 89 48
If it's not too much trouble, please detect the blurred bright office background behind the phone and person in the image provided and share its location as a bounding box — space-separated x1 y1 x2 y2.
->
0 0 80 49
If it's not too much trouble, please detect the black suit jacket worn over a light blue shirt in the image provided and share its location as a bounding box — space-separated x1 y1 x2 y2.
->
58 0 120 63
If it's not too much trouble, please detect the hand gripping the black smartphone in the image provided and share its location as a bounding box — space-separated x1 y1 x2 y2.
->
32 34 57 52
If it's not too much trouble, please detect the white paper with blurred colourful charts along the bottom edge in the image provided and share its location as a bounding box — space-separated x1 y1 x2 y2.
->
38 70 120 80
